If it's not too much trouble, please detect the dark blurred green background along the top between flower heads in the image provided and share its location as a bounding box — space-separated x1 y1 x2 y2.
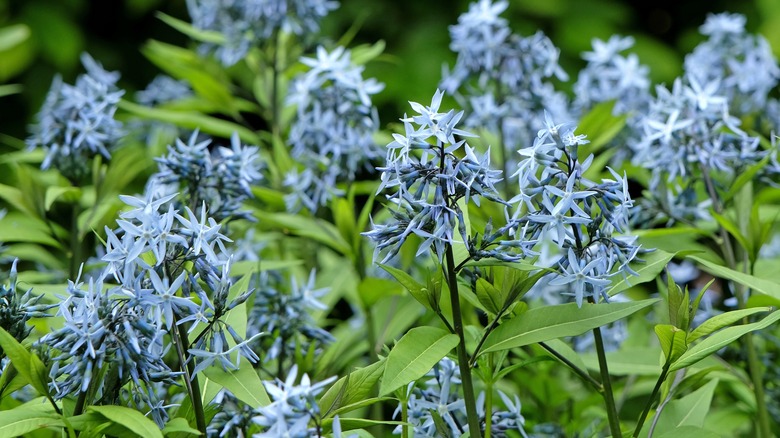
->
0 0 780 138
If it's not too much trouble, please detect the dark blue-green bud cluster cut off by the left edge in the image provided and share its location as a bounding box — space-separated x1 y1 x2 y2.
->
0 259 57 356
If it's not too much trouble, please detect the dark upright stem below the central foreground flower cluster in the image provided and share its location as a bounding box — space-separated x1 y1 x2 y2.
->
445 243 481 438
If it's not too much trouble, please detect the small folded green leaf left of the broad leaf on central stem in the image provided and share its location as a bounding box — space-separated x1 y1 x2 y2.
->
318 359 385 417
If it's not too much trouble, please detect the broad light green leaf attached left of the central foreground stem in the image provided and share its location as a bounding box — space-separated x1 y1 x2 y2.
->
379 327 458 396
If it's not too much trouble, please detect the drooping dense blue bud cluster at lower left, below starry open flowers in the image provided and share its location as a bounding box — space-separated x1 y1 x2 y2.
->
39 272 176 414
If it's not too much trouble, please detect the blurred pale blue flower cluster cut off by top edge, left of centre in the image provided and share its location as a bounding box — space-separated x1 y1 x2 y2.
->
187 0 338 66
